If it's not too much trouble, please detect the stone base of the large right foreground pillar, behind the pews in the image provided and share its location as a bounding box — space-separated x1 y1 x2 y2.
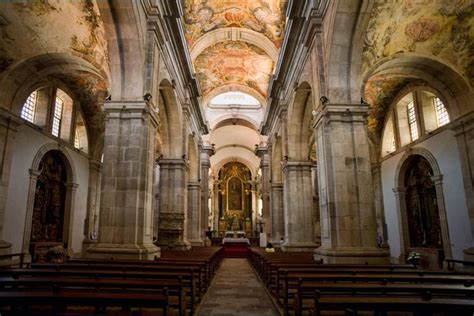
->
313 247 390 264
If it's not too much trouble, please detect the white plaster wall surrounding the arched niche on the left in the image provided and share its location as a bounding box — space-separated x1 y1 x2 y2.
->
2 125 89 253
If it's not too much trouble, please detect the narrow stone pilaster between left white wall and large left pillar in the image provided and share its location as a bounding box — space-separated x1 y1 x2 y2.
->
82 159 102 254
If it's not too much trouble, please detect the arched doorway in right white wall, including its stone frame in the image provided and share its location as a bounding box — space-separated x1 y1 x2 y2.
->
394 148 452 267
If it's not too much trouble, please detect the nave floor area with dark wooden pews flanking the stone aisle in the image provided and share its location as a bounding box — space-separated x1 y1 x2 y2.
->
0 244 474 316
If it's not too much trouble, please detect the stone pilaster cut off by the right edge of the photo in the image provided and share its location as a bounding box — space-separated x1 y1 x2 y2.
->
453 112 474 261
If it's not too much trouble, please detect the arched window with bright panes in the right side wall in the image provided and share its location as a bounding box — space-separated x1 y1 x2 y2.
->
382 89 450 156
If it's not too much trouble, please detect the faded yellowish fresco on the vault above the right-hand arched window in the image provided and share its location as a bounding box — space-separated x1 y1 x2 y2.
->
363 0 474 85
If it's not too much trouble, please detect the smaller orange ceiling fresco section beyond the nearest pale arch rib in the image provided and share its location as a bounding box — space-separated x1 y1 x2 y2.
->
194 41 274 97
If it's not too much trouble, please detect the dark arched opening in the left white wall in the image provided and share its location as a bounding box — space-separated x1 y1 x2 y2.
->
29 150 67 262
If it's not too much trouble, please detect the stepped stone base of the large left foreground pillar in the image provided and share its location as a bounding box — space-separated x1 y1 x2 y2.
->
86 243 161 260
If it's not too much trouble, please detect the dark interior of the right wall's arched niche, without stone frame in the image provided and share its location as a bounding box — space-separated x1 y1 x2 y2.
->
405 155 443 259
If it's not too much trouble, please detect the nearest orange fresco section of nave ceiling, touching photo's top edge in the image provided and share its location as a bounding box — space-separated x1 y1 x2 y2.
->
184 0 287 48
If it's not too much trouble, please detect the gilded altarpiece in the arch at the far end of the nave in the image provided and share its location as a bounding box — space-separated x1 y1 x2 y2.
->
219 162 252 232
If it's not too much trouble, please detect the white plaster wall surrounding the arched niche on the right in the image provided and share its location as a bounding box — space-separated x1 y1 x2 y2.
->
381 129 473 259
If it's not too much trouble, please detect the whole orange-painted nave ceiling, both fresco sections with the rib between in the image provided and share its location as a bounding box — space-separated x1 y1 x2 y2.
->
184 0 287 99
